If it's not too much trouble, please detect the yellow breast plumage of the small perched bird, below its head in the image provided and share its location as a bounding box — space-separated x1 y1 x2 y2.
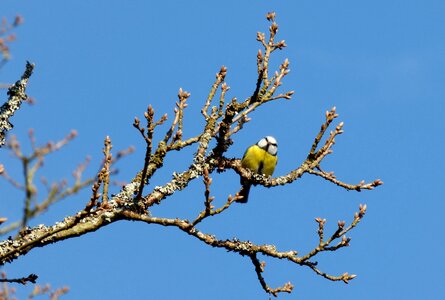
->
241 145 277 176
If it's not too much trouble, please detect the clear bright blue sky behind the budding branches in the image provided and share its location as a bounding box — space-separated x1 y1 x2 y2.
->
0 0 445 299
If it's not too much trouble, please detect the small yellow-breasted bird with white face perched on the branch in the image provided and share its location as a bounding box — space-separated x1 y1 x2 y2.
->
237 136 278 203
